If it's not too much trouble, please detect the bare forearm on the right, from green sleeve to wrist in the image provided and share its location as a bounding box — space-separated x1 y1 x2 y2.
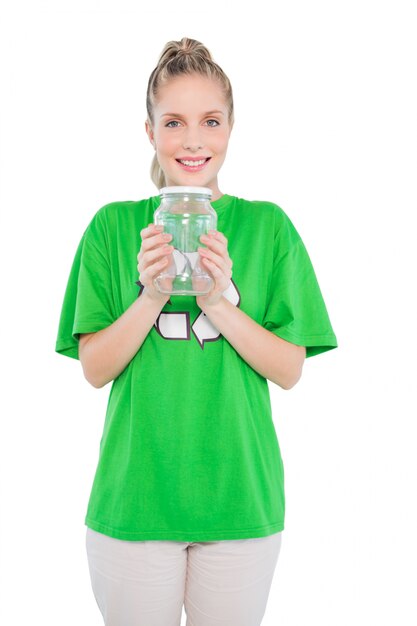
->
199 296 306 389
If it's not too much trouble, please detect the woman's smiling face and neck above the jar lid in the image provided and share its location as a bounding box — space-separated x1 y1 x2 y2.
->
145 74 232 200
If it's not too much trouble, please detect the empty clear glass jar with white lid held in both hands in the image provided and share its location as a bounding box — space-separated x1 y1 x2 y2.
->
153 185 217 296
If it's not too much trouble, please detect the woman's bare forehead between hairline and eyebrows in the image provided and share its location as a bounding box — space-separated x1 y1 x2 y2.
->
155 75 226 116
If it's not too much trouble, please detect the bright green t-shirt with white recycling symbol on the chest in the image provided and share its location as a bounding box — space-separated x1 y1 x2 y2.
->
56 194 337 541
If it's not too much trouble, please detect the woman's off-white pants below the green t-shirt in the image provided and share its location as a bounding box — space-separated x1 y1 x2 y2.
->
86 528 282 626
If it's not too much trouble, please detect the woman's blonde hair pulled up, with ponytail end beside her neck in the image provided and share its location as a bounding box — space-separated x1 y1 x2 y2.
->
146 37 234 190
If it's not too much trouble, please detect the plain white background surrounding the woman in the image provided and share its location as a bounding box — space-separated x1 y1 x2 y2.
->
0 0 417 626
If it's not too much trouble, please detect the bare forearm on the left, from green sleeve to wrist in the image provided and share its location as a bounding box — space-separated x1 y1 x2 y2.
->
79 288 169 389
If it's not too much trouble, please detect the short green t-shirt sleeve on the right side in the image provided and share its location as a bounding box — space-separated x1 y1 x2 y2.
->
262 207 337 357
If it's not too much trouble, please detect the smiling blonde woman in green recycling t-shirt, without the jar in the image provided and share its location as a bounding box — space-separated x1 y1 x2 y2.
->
56 38 337 626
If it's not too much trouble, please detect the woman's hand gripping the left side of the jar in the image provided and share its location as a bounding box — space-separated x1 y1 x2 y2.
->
137 223 174 302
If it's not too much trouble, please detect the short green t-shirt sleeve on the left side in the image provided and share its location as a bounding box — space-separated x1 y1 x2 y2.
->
55 214 116 359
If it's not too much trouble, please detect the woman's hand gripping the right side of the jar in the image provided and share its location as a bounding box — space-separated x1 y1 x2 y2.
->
196 230 233 306
